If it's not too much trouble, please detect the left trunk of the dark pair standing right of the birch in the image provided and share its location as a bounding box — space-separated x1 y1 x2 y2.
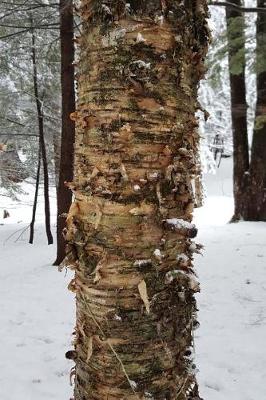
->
226 0 249 220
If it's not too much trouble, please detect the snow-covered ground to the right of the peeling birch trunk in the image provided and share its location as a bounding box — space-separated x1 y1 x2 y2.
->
195 160 266 400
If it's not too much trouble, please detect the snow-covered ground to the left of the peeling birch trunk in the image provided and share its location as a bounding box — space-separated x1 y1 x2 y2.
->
0 184 74 400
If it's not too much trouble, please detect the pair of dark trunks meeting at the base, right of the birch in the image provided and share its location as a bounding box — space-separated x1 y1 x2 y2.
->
226 0 266 221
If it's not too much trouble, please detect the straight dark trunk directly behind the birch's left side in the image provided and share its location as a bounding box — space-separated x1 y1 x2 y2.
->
54 0 75 265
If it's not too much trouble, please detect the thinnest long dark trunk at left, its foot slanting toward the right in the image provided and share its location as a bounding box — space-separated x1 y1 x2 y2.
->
31 25 53 244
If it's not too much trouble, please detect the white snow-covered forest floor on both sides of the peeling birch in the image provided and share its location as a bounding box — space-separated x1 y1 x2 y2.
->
0 159 266 400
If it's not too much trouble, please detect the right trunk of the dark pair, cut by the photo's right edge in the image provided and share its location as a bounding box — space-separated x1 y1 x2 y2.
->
244 0 266 221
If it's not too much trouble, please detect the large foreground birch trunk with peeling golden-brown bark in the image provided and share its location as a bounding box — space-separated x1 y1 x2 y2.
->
67 0 209 400
